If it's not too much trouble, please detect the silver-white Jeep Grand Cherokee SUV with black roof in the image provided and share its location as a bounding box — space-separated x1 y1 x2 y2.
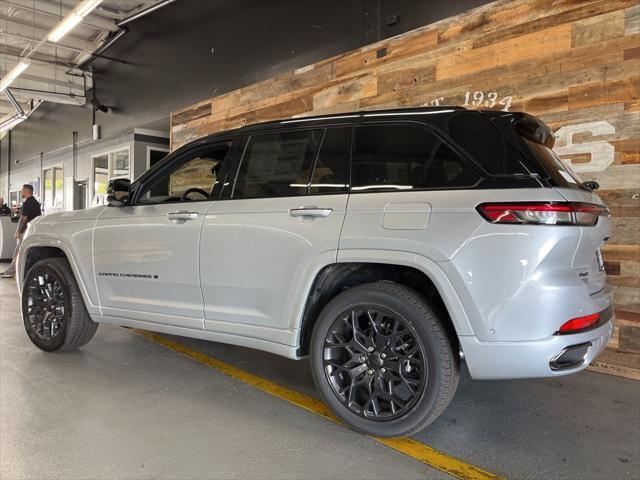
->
18 107 614 436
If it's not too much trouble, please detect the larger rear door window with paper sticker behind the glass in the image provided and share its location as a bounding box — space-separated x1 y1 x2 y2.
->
233 130 322 198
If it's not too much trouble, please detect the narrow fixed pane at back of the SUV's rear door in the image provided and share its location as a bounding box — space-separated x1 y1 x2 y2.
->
309 127 351 194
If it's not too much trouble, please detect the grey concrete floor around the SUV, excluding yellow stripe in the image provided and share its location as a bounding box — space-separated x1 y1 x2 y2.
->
0 274 640 480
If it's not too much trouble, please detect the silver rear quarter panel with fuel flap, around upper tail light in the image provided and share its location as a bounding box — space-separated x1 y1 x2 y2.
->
338 188 584 341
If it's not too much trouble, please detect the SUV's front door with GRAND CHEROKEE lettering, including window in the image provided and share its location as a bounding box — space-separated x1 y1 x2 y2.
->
94 140 238 330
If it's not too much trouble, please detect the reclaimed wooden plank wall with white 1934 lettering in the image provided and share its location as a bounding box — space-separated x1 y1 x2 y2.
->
171 0 640 378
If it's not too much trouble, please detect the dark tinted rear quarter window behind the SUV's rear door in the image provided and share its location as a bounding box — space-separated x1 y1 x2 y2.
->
351 124 480 191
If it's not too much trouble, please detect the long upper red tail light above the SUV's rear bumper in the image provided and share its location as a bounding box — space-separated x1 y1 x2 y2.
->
476 202 611 227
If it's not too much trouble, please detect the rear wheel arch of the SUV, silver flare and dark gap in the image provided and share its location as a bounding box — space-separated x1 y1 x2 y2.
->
297 251 473 356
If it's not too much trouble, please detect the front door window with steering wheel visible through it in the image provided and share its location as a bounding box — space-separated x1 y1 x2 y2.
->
138 142 231 204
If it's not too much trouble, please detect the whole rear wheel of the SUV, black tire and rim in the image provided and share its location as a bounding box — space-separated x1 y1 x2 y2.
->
310 282 460 437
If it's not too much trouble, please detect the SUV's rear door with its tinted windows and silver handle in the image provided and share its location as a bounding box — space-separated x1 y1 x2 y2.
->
200 126 351 344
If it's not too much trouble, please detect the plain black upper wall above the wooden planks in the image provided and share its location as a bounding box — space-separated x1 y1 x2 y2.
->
6 0 489 158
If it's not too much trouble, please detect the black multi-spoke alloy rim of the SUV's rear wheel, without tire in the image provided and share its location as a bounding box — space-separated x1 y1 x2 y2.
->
323 307 428 421
